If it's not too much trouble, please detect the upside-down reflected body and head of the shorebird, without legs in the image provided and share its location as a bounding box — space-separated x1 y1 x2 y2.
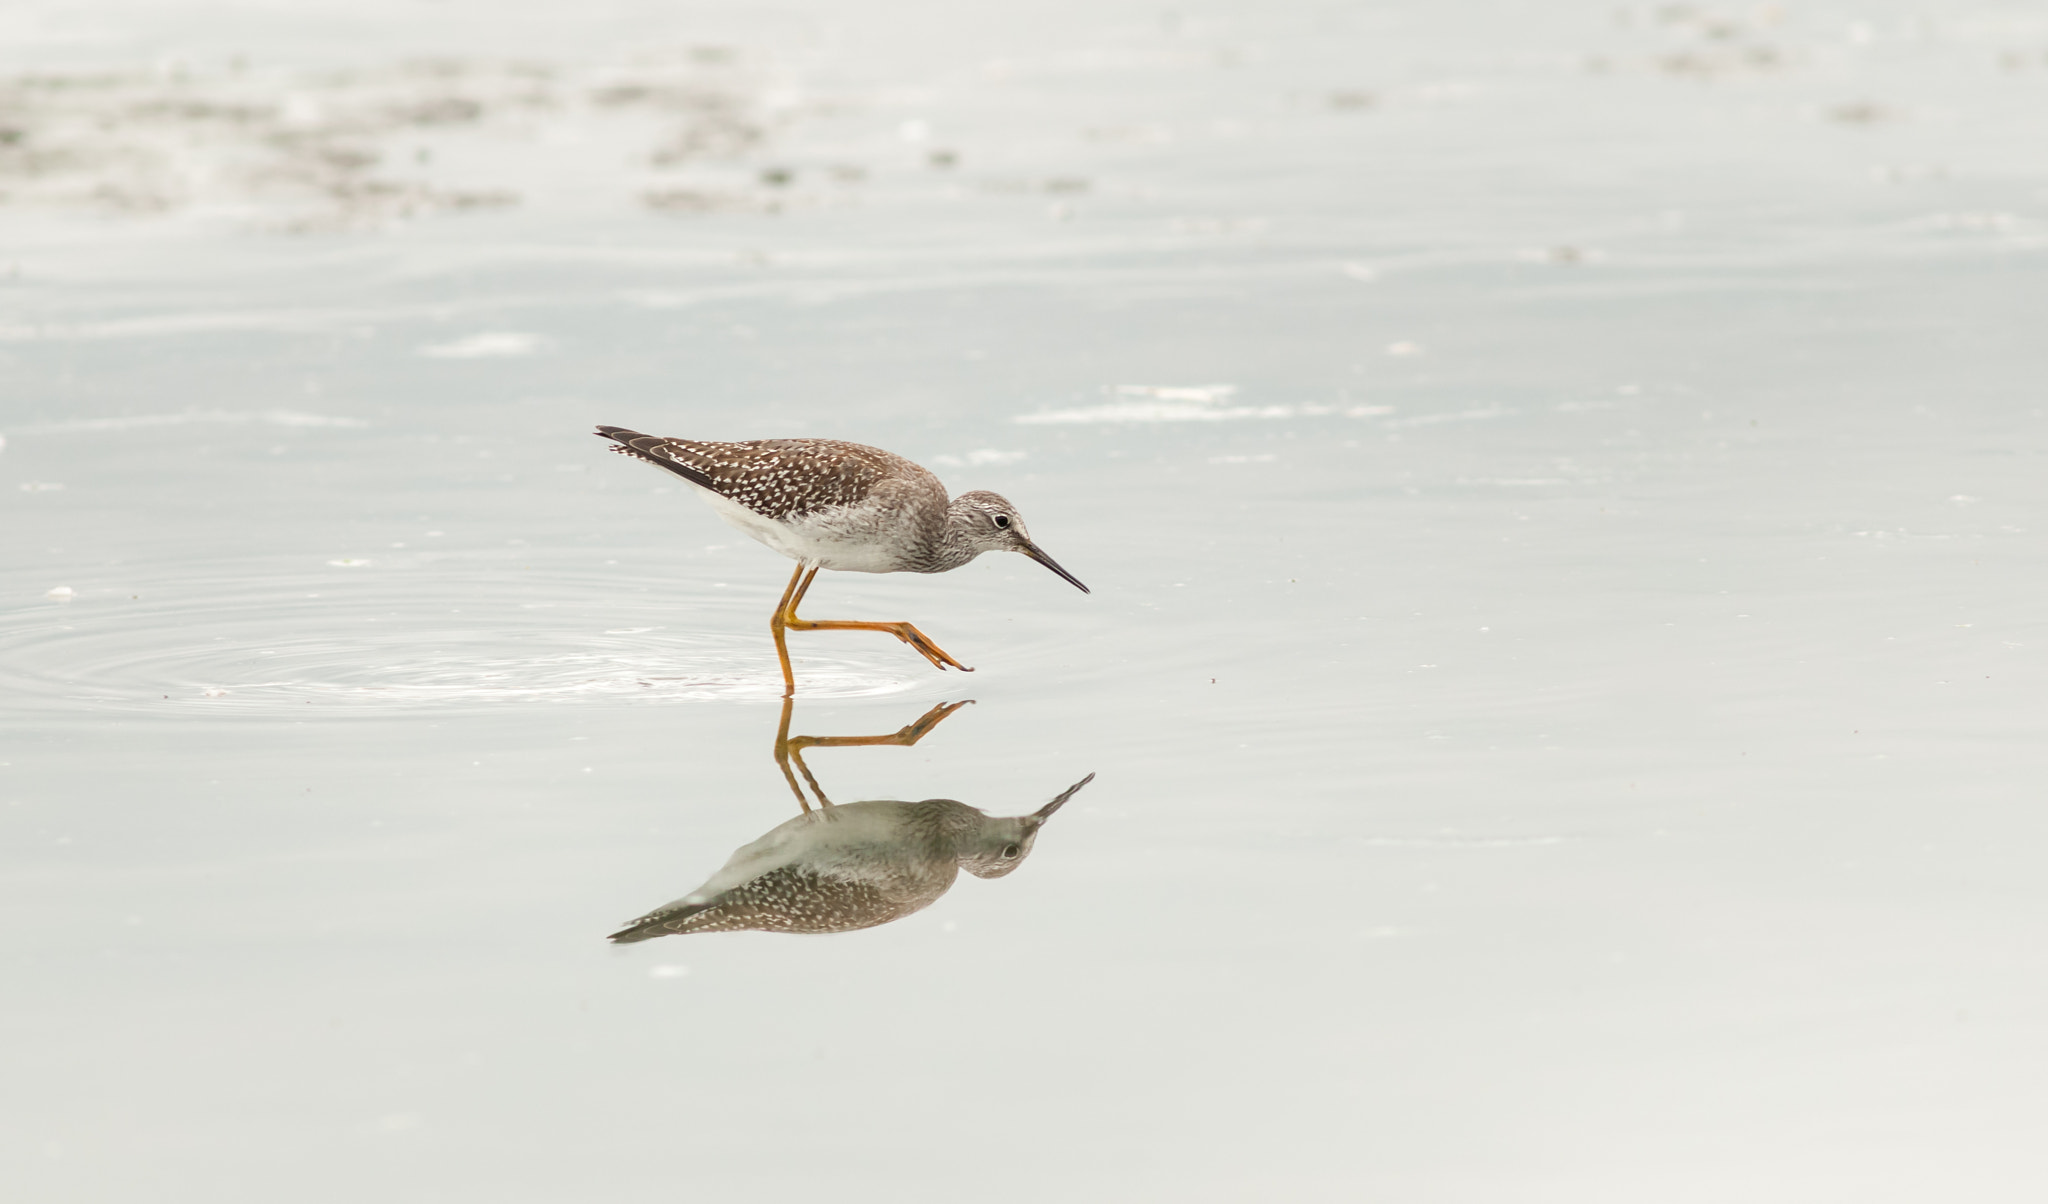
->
610 774 1096 944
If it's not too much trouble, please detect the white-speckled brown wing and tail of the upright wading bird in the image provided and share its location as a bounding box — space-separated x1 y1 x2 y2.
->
598 426 946 522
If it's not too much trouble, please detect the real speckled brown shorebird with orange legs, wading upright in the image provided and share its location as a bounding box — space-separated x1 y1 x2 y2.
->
598 426 1087 690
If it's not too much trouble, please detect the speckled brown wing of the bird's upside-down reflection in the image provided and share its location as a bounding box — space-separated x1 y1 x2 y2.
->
610 866 954 944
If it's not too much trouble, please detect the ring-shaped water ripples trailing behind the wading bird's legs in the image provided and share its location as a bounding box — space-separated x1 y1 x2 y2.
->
0 565 913 717
